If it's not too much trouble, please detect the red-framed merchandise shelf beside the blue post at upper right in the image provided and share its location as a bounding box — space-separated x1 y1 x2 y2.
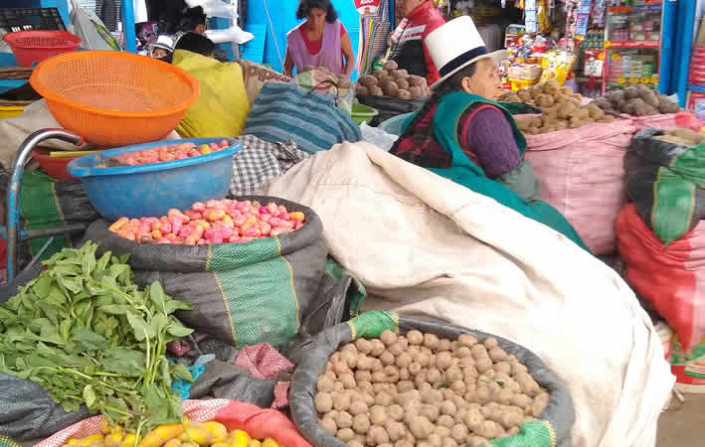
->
602 0 663 93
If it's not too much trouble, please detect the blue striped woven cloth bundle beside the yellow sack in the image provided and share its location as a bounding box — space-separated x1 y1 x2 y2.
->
243 83 362 153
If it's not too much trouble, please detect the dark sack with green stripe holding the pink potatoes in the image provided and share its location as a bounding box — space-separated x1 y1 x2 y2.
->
86 196 330 347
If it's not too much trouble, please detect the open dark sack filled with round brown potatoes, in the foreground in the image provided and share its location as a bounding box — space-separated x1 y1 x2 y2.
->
290 312 574 447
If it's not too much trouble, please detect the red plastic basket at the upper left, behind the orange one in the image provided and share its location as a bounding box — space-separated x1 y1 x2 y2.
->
2 31 83 67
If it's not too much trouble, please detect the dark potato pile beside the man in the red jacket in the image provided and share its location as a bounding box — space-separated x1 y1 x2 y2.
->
355 61 431 100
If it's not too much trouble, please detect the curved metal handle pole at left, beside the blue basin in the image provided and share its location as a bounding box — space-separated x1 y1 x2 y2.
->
5 129 83 282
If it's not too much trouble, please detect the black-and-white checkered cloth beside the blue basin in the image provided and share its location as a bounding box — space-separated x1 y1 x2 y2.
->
230 135 310 196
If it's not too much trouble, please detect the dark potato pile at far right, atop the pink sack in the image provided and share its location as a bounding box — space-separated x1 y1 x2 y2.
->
593 85 680 116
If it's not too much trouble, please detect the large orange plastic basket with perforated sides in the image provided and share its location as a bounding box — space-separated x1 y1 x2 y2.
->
29 51 198 147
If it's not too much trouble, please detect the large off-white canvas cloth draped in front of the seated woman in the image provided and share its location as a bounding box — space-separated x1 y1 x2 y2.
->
265 143 674 447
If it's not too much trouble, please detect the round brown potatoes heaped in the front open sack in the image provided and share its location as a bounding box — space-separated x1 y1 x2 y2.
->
314 330 549 447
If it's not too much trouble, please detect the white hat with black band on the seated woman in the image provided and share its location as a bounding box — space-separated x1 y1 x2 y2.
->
426 16 508 89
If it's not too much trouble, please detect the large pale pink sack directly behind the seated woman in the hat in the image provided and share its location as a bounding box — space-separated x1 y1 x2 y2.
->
526 119 636 255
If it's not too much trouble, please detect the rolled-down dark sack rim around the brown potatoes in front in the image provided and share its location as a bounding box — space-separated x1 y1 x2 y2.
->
289 311 575 447
